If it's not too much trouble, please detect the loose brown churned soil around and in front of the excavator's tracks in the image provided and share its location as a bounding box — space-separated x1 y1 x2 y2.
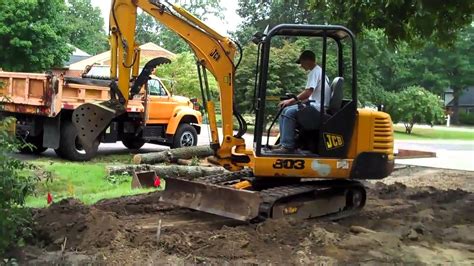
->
7 168 474 265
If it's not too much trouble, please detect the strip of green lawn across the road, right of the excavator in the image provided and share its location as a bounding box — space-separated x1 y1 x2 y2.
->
394 125 474 140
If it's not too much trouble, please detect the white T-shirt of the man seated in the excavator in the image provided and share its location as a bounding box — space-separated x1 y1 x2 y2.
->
305 65 331 111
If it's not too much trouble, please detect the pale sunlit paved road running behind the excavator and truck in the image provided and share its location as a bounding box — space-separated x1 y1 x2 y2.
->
19 123 474 171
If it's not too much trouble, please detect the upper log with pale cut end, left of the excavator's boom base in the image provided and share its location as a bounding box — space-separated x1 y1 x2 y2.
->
133 146 214 164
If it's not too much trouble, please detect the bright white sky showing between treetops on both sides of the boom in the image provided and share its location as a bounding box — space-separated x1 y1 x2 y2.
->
91 0 242 35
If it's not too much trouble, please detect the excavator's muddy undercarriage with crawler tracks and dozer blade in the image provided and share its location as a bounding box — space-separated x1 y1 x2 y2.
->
160 170 366 222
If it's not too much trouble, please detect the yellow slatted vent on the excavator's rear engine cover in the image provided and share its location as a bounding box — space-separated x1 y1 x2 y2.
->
373 113 393 155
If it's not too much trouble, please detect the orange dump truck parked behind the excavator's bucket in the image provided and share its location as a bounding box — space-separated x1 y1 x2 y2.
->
0 71 202 161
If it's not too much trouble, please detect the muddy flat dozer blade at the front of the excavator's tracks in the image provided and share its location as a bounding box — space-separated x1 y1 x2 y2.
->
160 178 262 221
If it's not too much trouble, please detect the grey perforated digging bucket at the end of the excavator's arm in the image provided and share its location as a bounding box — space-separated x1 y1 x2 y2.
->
72 100 125 149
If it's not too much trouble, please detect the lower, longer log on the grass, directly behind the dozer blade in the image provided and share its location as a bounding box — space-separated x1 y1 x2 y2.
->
106 164 227 179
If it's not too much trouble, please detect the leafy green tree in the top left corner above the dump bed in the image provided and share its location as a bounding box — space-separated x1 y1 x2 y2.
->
0 0 71 72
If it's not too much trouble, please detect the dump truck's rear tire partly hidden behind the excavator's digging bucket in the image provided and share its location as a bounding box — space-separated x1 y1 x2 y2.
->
55 121 99 161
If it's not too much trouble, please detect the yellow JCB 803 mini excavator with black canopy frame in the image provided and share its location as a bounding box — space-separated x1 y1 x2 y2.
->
73 0 394 221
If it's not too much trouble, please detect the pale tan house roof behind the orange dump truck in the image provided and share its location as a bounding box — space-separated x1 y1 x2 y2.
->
58 42 176 77
